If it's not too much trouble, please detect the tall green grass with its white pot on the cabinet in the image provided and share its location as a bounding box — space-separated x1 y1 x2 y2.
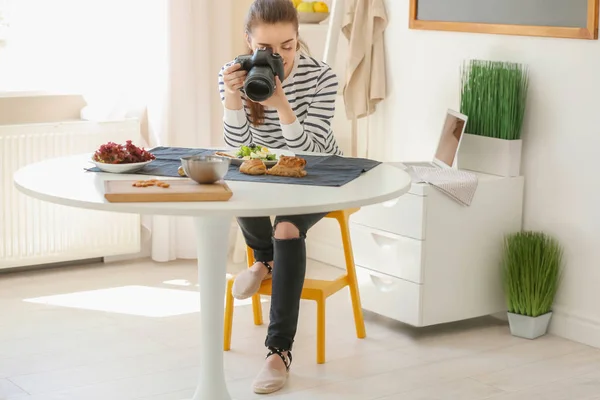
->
457 60 529 176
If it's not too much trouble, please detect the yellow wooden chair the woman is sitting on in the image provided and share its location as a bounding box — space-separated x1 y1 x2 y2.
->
223 208 366 364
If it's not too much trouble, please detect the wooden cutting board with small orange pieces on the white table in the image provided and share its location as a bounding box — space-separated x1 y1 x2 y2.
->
104 179 233 203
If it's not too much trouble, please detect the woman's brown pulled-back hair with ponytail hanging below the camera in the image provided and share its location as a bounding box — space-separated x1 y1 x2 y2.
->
245 0 309 126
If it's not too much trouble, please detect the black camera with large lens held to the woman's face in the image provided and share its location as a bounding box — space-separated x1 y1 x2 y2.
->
235 48 284 102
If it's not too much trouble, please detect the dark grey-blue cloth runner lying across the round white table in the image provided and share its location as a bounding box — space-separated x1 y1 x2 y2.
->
88 147 381 187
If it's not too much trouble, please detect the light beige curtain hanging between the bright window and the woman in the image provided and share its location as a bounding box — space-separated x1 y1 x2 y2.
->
143 0 232 261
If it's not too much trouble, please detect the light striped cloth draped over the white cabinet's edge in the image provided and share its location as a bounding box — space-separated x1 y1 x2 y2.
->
409 166 478 206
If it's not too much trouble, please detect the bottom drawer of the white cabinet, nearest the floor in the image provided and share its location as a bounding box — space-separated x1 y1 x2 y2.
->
356 266 422 326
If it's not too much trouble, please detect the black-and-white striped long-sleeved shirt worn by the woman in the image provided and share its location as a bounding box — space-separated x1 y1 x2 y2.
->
219 54 342 155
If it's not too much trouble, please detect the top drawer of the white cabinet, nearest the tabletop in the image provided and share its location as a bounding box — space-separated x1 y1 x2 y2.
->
351 193 426 239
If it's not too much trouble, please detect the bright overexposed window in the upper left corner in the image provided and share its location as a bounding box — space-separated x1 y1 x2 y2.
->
0 0 167 93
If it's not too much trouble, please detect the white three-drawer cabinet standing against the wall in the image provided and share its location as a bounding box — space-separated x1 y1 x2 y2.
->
351 164 524 326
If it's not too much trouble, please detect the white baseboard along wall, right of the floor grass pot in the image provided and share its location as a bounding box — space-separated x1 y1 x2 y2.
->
549 307 600 348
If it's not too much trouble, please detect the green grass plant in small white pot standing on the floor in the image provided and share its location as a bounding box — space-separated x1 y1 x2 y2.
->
503 232 563 339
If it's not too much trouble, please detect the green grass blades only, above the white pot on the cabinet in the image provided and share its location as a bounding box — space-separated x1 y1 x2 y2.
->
460 60 529 140
